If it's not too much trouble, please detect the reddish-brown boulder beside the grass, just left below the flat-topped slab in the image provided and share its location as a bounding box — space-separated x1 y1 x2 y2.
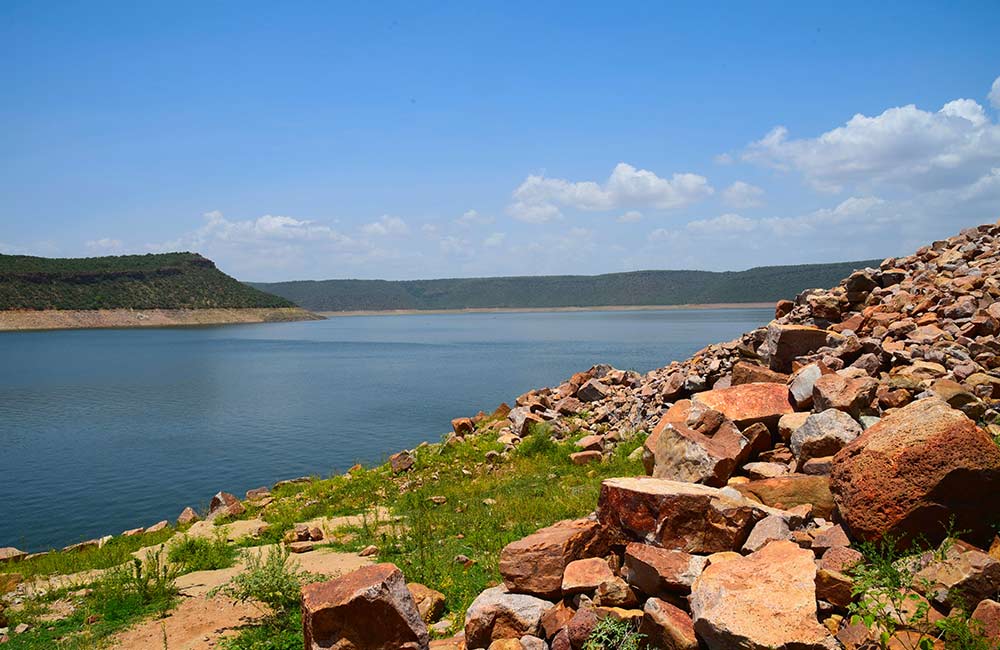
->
500 519 607 598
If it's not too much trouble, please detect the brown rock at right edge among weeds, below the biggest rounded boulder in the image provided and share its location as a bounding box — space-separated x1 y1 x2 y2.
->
914 540 1000 611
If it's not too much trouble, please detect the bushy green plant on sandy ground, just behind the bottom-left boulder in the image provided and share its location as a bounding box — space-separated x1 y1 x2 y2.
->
211 545 316 629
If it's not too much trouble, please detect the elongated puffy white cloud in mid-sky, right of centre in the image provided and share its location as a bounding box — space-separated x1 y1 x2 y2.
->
508 163 713 223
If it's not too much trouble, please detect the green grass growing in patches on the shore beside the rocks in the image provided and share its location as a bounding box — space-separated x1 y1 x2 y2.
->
4 418 644 650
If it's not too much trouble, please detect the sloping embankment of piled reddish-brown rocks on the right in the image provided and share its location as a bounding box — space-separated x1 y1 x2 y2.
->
303 224 1000 650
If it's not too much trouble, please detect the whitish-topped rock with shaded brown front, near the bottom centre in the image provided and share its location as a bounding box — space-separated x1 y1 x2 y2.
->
465 587 554 648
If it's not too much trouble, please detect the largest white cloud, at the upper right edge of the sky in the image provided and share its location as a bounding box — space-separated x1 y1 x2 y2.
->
743 90 1000 192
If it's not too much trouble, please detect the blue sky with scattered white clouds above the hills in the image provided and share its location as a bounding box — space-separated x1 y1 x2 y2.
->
0 0 1000 281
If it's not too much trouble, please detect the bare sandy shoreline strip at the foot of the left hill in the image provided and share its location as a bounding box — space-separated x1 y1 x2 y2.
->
0 307 322 331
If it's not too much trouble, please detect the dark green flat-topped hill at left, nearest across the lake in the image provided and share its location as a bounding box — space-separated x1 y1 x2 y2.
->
0 253 294 310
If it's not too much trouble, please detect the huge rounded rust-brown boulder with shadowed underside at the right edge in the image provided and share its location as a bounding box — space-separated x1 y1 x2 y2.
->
831 398 1000 544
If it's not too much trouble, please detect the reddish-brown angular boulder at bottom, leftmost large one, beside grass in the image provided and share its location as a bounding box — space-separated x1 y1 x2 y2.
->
302 564 430 650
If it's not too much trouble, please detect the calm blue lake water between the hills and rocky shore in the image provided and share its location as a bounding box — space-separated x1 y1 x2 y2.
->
0 309 773 550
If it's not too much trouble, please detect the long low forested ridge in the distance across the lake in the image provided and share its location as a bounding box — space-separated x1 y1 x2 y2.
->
252 260 881 311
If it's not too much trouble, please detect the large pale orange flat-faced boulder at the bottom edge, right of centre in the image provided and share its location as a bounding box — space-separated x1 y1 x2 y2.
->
691 541 835 650
